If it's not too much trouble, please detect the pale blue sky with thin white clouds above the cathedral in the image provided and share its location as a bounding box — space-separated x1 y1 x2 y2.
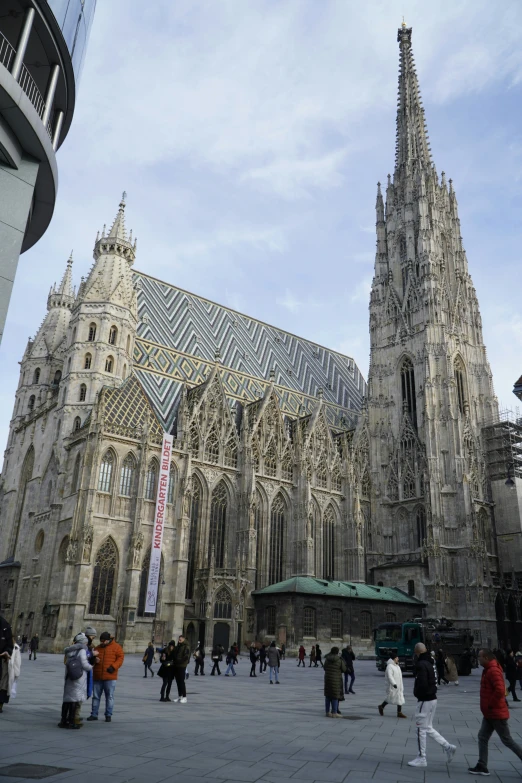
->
0 0 522 444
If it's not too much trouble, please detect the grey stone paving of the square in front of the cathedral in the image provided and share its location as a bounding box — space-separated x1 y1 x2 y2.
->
0 654 522 783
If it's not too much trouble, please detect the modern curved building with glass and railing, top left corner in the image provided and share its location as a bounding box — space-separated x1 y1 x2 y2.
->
0 0 96 340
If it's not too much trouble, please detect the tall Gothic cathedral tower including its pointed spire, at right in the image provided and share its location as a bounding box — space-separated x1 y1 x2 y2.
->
366 24 498 641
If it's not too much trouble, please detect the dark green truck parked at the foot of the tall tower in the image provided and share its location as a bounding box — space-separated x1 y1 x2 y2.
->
373 618 478 676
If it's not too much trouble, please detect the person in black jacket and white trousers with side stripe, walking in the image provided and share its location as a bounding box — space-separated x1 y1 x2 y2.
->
408 642 457 767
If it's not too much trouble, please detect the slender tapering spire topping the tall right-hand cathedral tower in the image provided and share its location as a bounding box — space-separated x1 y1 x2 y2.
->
395 22 431 174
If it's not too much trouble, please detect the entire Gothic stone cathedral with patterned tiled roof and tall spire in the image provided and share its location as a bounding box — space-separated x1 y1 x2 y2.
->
0 26 522 651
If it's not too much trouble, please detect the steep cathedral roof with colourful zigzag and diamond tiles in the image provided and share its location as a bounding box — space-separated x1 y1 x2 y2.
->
134 271 366 429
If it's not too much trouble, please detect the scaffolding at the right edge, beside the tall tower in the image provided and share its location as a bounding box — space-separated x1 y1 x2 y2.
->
482 408 522 481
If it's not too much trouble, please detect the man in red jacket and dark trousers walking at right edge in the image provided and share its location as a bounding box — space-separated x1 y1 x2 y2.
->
468 650 522 775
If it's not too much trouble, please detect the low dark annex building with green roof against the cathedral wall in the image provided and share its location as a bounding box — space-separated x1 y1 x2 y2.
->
252 576 426 654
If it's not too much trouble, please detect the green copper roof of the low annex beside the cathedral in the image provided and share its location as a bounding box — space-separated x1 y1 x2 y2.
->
253 576 424 606
